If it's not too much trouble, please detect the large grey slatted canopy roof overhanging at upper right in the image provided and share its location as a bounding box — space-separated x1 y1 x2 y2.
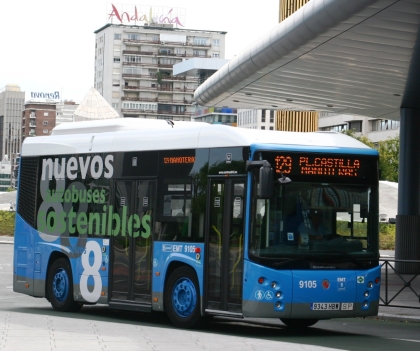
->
195 0 420 119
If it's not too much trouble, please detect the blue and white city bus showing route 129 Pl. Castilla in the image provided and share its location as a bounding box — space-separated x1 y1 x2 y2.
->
13 118 380 328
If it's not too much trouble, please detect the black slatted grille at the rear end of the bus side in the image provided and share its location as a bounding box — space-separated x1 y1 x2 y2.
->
17 157 38 228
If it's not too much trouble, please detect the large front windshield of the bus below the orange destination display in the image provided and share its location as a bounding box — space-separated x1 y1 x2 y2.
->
249 182 378 266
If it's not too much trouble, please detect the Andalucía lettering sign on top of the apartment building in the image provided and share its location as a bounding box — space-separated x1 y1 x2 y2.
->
106 3 186 27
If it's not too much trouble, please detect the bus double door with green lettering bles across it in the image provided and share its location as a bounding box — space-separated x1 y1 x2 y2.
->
107 180 156 311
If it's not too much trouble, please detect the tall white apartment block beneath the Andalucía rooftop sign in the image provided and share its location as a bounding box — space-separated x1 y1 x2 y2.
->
94 23 226 121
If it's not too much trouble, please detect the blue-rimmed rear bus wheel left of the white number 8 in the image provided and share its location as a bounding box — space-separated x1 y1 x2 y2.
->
47 258 83 312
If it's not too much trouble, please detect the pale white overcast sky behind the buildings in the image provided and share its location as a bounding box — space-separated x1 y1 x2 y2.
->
0 0 279 103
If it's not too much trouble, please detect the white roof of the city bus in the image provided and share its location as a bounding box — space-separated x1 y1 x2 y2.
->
22 118 371 157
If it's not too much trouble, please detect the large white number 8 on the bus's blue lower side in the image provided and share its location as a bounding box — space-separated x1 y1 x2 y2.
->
80 241 102 302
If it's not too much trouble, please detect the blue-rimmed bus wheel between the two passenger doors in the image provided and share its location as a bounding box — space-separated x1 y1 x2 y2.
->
164 266 204 328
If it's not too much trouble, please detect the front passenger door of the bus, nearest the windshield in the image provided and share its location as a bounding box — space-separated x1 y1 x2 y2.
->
204 177 246 315
